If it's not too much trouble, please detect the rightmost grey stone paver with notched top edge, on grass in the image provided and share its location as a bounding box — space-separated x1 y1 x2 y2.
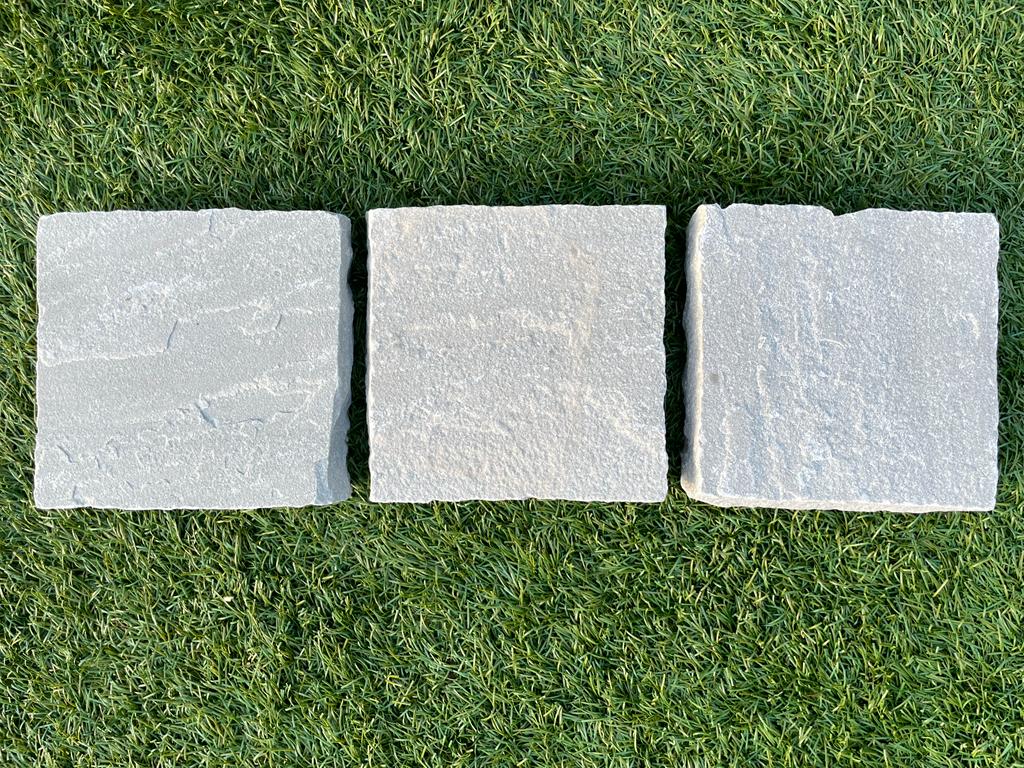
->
683 205 998 512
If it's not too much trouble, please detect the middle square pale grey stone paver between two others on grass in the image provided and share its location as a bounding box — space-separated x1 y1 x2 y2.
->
367 206 668 502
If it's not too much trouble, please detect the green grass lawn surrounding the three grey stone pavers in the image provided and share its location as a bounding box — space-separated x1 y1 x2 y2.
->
0 0 1024 766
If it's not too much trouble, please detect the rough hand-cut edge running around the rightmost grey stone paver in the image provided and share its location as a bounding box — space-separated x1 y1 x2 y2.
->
680 203 999 514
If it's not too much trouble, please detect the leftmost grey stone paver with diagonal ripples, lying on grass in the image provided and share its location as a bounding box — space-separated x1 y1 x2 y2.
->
35 209 352 509
